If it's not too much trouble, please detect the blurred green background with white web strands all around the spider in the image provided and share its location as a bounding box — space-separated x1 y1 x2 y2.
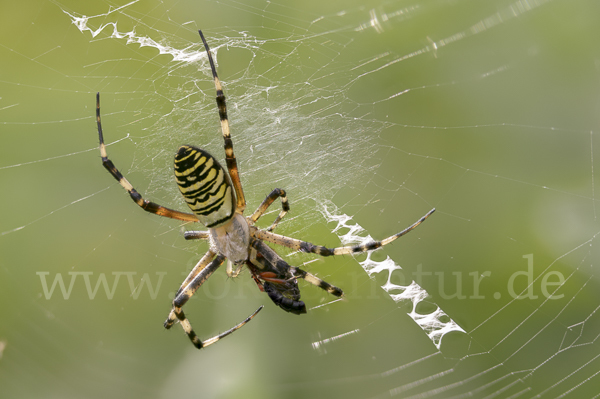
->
0 0 600 398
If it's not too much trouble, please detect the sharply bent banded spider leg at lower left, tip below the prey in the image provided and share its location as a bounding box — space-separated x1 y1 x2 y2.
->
165 251 263 349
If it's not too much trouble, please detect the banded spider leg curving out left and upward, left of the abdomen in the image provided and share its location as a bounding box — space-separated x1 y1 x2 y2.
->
96 93 198 222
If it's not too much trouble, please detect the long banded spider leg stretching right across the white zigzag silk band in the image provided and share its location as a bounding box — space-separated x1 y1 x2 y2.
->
252 208 435 256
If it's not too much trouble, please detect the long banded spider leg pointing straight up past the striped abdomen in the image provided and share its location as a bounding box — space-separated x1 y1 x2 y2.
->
198 30 246 214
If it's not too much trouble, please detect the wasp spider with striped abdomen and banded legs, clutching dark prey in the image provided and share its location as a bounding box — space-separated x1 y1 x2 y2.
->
96 31 435 349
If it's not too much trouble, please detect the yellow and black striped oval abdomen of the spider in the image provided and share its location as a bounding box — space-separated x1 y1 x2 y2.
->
175 145 236 228
